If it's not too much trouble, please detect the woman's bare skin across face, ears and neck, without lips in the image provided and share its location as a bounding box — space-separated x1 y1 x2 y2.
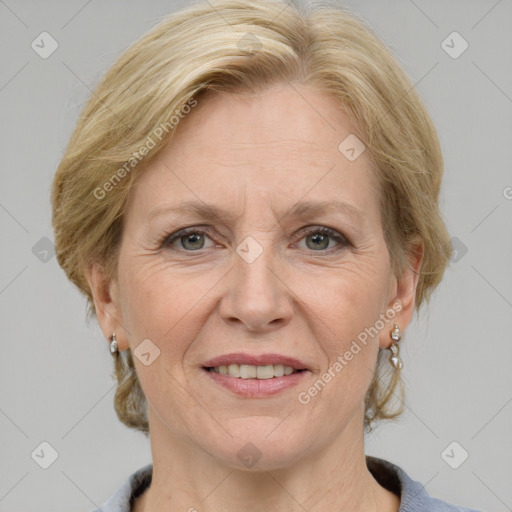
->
88 84 421 512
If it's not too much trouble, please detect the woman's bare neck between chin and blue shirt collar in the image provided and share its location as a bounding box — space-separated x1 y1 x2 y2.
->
133 408 400 512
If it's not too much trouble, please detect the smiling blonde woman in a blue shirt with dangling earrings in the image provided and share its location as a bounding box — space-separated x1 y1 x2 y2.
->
52 0 484 512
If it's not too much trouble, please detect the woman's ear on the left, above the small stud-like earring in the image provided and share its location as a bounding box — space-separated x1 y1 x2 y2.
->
86 262 129 351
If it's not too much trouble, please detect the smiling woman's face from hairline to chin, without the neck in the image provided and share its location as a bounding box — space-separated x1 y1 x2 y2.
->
96 85 420 469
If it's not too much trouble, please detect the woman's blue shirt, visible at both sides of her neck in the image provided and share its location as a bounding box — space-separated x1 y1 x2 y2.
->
92 455 480 512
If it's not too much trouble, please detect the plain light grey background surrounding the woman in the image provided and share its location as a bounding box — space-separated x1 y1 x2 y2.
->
0 0 512 512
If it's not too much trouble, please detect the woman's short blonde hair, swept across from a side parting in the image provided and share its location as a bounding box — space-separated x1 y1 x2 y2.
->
51 0 451 434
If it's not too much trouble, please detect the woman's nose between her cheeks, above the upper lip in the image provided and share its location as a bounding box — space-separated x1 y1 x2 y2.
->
220 242 293 333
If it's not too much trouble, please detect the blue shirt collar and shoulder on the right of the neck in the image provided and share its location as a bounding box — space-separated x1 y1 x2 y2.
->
366 455 481 512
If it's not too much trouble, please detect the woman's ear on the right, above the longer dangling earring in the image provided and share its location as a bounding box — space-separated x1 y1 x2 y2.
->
379 240 424 348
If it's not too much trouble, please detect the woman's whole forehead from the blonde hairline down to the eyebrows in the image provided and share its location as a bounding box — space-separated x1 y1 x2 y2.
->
124 84 377 222
